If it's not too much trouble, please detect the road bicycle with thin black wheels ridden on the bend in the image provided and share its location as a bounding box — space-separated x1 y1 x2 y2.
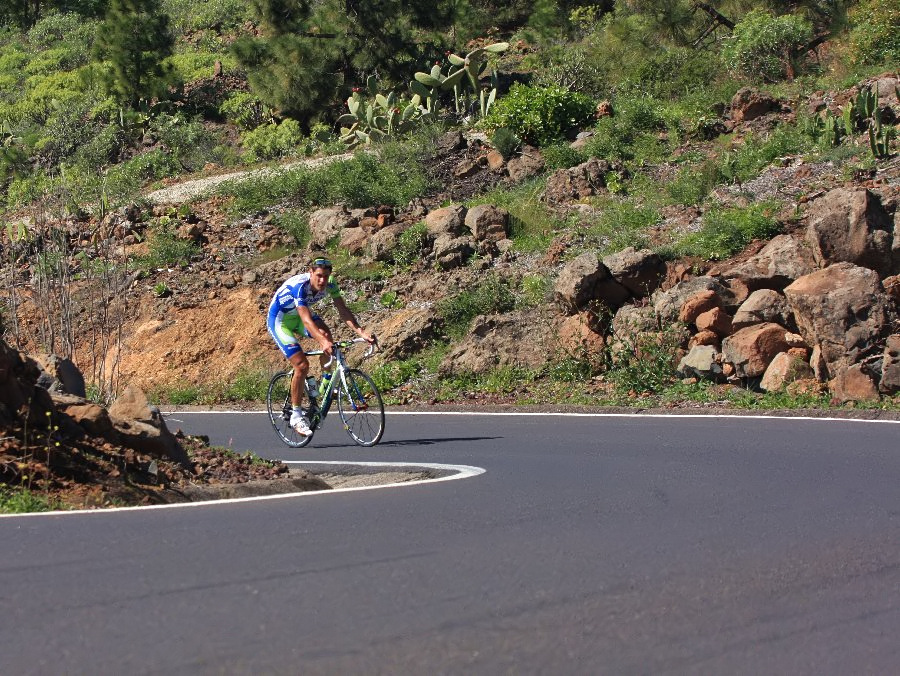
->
266 338 384 448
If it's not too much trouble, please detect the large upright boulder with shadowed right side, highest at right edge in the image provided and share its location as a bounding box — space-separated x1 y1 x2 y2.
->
806 188 893 277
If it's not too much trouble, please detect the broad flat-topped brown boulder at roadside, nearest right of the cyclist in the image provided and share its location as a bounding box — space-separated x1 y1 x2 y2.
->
439 311 550 374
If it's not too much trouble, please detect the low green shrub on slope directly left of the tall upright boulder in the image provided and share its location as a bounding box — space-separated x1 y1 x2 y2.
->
675 202 779 260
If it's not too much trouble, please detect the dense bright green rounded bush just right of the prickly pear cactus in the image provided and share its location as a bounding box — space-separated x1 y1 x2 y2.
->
485 84 594 146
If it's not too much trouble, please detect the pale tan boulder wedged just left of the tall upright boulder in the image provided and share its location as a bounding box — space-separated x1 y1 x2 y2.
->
710 235 817 292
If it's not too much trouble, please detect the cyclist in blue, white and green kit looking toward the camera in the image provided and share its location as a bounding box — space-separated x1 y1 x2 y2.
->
267 258 375 437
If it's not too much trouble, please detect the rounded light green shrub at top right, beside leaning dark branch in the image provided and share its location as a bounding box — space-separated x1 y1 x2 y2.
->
722 9 813 82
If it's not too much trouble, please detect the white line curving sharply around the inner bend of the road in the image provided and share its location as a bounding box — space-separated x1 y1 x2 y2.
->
0 460 487 519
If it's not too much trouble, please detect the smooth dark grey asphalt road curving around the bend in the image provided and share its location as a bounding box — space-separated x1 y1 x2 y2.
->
0 413 900 675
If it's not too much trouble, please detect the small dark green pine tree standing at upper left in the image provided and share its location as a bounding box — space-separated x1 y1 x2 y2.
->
95 0 174 108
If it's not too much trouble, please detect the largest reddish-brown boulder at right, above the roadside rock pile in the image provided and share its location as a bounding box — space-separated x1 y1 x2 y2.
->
784 263 894 376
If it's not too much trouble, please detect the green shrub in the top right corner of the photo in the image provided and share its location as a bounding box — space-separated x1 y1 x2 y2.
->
849 0 900 67
